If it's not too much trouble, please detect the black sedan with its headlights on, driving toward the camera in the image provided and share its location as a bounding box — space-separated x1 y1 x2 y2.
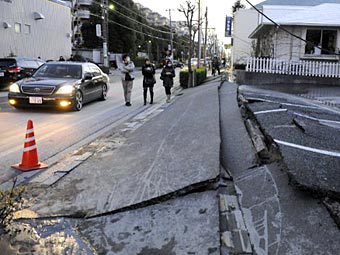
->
8 62 109 111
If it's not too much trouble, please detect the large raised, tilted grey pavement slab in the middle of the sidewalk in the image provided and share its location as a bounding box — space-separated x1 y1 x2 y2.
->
31 84 220 217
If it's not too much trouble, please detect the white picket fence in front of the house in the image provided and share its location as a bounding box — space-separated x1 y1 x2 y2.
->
246 58 340 78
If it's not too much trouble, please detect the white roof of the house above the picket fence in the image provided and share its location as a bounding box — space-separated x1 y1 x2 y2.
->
249 4 340 38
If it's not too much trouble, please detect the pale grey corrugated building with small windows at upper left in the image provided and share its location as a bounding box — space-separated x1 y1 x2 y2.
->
0 0 72 60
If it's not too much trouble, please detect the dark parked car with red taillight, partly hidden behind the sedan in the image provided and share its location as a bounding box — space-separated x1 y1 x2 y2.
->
0 57 45 90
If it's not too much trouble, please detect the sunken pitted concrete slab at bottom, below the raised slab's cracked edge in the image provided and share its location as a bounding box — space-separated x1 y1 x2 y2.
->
77 191 220 255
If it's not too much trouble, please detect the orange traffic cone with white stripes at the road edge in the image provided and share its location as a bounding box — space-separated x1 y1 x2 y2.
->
12 120 48 171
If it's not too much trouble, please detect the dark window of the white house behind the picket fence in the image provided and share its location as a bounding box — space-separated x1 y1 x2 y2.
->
305 29 337 55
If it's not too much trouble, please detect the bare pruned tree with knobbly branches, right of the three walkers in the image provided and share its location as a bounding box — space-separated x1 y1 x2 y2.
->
178 0 196 87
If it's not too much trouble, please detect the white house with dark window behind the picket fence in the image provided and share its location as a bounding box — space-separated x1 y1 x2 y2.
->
250 4 340 61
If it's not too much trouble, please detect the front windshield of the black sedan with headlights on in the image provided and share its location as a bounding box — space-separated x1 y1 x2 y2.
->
33 64 82 79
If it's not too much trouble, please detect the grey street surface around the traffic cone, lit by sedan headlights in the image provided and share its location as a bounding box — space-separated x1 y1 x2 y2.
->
0 68 178 184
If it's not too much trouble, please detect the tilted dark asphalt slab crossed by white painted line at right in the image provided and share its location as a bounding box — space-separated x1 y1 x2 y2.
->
244 99 340 199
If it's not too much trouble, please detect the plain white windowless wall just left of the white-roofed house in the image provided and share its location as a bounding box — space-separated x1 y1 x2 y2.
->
232 9 258 63
